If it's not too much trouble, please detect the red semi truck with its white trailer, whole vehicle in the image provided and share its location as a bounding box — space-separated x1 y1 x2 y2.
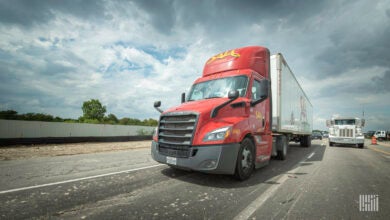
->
151 46 312 180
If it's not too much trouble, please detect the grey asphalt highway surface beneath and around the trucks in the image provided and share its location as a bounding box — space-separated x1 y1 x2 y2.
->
0 140 390 219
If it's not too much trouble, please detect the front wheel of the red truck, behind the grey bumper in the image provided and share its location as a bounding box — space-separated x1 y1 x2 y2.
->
234 138 256 181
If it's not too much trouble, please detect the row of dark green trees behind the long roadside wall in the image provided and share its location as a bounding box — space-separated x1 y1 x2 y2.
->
0 99 158 126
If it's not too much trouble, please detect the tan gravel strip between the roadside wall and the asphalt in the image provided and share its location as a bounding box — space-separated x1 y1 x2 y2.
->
0 141 151 160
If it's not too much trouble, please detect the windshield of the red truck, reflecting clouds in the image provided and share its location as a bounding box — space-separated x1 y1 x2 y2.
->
187 76 248 101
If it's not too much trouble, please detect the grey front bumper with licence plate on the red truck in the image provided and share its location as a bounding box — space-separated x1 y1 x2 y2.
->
151 141 240 174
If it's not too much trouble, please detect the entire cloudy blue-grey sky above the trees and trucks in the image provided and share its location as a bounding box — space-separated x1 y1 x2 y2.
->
0 0 390 130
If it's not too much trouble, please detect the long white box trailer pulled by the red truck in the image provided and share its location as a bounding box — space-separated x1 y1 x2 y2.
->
270 53 313 146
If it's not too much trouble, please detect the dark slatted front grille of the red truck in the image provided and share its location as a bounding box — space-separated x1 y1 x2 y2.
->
158 114 197 158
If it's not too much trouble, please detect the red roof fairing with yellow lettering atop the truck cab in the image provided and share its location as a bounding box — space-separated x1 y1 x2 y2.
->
203 46 270 77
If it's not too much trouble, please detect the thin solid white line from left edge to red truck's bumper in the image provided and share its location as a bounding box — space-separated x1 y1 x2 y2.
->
0 164 165 194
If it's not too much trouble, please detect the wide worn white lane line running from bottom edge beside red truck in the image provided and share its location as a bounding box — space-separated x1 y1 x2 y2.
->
233 152 315 220
